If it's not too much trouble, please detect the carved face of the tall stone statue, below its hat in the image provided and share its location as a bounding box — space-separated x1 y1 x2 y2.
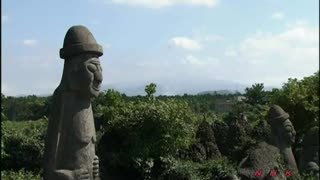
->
67 53 103 97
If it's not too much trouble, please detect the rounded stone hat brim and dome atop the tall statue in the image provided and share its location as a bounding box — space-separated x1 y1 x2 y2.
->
60 25 103 59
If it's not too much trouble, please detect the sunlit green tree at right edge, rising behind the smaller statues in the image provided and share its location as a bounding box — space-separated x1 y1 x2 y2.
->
269 71 319 141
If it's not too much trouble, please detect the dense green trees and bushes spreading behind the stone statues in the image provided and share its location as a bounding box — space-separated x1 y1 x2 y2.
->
1 71 319 180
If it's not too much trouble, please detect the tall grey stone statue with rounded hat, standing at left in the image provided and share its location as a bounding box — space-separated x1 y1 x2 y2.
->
44 26 103 180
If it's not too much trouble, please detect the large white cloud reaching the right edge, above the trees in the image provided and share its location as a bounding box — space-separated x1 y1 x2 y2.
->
239 23 319 61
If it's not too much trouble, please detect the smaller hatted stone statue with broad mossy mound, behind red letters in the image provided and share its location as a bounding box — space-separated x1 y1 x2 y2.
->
239 105 298 179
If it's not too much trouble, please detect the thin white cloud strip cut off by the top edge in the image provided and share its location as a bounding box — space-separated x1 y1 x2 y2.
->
111 0 218 8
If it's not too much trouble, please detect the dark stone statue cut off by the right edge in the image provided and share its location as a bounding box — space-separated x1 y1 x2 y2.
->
300 127 319 178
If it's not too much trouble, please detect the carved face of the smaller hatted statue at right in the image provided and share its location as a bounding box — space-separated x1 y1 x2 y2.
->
280 119 296 145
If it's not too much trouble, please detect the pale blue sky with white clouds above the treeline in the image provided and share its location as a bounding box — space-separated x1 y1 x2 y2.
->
1 0 319 95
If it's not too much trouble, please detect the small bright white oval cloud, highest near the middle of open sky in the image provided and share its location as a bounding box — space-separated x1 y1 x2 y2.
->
169 37 201 50
